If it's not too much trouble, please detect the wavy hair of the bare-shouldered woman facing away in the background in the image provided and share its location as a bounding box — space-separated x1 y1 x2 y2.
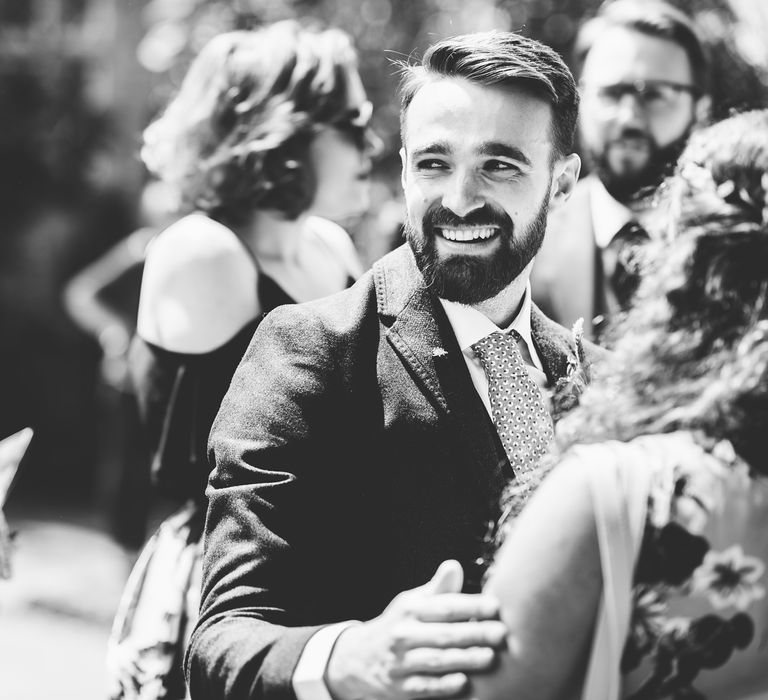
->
141 20 364 225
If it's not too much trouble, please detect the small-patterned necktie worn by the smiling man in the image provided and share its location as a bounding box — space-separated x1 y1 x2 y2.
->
472 331 554 487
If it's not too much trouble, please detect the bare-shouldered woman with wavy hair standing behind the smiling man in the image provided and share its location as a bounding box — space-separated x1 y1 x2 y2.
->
108 21 372 700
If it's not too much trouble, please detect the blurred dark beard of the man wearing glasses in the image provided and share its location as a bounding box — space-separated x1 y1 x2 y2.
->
584 127 691 204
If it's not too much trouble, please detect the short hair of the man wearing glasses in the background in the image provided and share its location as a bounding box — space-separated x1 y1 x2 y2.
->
574 0 710 95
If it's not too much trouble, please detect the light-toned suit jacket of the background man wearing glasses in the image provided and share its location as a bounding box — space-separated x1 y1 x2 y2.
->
531 175 597 337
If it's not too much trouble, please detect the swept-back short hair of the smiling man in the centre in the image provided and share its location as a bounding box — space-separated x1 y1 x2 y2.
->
400 31 579 155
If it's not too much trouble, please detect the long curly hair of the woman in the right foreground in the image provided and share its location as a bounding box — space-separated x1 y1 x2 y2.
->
559 110 768 473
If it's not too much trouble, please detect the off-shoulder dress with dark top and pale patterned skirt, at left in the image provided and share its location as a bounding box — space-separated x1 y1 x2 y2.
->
107 273 354 700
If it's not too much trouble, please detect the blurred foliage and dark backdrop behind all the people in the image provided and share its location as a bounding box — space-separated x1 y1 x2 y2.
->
0 0 768 516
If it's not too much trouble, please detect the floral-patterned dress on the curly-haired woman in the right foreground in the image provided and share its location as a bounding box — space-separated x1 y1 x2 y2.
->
572 431 768 700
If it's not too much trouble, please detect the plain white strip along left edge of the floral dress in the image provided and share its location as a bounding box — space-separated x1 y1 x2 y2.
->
574 441 653 700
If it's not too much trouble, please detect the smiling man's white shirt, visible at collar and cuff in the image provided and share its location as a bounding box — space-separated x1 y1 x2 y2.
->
291 280 544 700
